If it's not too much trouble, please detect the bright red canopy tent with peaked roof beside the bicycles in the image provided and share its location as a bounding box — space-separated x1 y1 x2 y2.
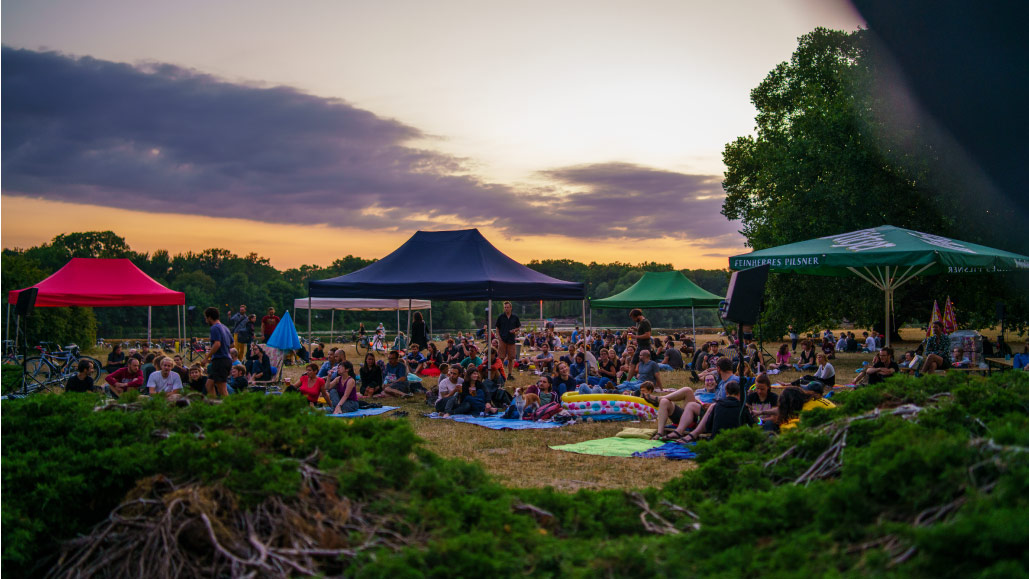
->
7 257 186 341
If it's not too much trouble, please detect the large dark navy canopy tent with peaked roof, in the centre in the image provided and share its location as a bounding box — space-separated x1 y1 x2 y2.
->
308 229 586 367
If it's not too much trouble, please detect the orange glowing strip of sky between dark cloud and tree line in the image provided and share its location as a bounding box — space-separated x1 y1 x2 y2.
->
0 195 747 269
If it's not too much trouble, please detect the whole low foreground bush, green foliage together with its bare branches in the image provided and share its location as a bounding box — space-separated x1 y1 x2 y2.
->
2 372 1029 577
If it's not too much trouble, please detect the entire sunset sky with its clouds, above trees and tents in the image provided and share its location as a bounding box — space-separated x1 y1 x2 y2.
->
0 0 863 267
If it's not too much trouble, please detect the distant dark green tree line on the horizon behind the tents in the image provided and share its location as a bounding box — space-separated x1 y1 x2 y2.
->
0 231 729 346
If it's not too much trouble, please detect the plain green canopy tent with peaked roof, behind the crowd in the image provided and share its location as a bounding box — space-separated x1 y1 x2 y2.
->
590 272 725 341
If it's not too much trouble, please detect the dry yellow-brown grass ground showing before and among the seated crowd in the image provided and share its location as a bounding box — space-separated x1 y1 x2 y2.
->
98 330 971 492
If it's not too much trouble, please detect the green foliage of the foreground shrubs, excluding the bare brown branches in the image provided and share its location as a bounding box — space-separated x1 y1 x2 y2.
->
2 366 1029 577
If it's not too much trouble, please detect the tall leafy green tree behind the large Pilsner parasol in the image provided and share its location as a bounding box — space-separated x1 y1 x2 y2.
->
722 28 1029 334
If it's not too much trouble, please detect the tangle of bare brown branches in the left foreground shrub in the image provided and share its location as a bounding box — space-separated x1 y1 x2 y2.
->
48 453 424 578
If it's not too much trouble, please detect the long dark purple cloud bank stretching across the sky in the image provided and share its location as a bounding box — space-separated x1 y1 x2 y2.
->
2 47 733 243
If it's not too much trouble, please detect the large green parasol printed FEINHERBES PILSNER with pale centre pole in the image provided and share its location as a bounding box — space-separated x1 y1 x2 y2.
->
729 225 1029 345
